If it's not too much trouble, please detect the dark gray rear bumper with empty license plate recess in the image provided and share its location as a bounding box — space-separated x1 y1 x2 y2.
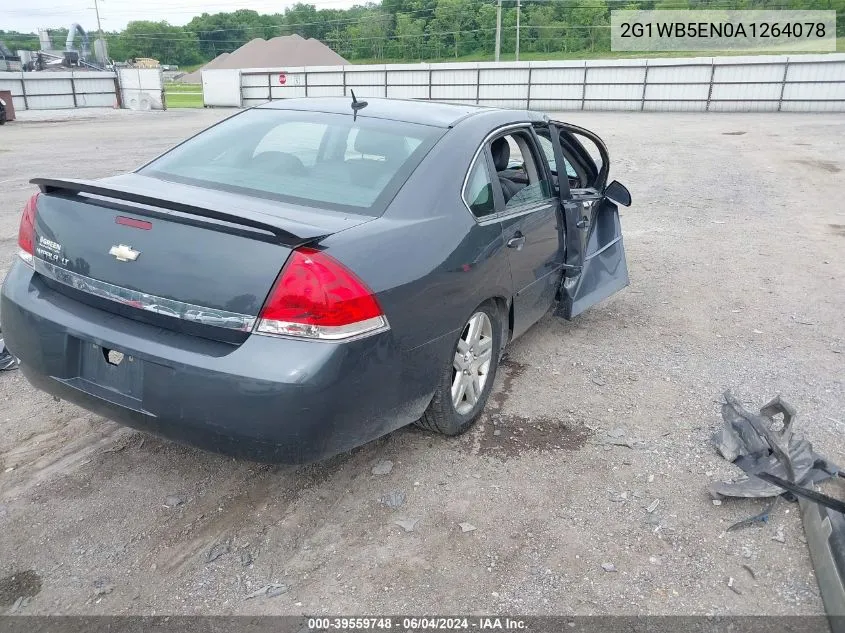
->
0 262 448 463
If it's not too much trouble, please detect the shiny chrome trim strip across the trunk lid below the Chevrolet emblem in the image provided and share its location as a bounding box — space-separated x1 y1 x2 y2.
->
33 257 256 332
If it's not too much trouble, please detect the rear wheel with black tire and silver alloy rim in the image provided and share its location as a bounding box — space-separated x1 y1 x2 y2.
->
416 301 502 435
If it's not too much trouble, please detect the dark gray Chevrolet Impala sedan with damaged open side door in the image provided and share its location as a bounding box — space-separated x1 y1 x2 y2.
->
0 98 630 463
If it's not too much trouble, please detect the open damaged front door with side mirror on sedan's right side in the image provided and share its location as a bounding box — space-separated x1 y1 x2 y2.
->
551 121 631 319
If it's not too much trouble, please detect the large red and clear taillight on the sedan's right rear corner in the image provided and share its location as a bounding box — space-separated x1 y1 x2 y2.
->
255 248 388 340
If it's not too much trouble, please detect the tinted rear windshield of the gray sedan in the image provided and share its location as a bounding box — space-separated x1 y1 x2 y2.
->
140 108 443 215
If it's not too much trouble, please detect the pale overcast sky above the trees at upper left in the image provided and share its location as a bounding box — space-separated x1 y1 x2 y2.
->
0 0 355 33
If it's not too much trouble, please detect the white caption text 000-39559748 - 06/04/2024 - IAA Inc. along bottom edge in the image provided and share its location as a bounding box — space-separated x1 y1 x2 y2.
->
308 617 528 633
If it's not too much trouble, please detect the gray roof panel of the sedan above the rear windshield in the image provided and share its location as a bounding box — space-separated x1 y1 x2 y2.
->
257 96 502 127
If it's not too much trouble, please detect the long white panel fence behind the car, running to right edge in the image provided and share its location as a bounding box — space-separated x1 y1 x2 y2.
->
203 54 845 112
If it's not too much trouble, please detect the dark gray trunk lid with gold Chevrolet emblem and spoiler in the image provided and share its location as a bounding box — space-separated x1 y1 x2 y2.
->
28 174 372 342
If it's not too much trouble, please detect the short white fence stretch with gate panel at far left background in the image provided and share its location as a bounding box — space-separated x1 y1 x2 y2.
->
0 68 164 112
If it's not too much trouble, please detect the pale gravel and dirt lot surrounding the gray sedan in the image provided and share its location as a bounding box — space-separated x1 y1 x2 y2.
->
0 111 845 614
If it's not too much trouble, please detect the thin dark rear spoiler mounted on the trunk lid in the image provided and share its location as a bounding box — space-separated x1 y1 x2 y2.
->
29 178 326 248
